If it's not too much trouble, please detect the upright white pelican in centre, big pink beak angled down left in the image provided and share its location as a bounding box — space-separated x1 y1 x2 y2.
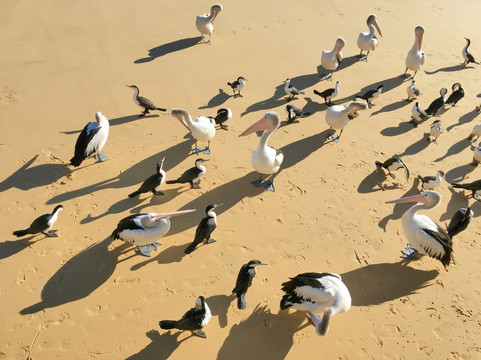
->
239 111 284 191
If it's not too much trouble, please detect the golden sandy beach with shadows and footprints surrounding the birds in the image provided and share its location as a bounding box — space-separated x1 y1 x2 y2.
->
0 0 481 360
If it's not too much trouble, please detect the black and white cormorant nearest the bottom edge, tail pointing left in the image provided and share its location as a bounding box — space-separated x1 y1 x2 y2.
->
159 296 212 339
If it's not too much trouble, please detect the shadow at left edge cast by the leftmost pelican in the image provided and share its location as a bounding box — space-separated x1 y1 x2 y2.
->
0 155 70 192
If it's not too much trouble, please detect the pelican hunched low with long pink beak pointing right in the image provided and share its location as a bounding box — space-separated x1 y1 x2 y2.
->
111 209 195 256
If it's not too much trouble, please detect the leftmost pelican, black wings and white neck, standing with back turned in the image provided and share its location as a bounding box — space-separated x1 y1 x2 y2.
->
70 111 109 167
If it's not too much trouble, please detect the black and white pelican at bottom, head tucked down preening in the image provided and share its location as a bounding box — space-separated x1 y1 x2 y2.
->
281 272 351 335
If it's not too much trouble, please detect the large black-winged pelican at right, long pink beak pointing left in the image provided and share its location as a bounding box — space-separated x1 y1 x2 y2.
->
387 190 454 267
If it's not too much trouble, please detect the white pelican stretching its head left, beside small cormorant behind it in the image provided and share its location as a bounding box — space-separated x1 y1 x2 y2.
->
171 109 215 154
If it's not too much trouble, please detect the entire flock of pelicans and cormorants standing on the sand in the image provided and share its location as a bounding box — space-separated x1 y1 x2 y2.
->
8 4 481 346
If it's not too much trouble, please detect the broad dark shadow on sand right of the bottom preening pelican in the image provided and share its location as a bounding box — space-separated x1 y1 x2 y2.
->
341 261 439 306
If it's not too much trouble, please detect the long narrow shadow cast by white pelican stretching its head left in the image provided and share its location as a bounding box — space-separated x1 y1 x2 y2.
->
47 139 193 205
